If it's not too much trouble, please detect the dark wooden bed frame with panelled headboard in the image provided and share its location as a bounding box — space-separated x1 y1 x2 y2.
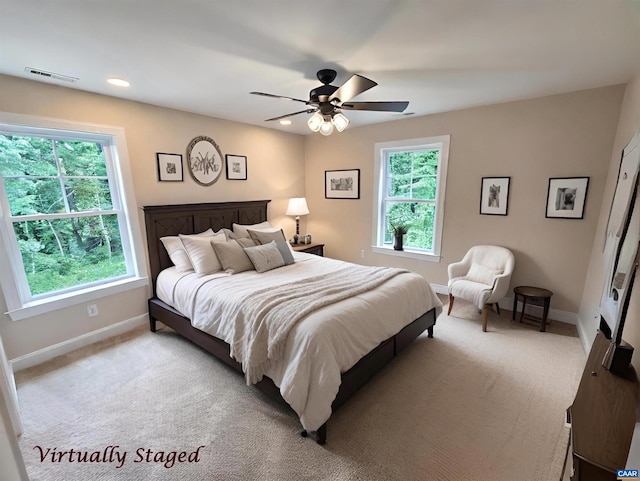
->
143 200 436 444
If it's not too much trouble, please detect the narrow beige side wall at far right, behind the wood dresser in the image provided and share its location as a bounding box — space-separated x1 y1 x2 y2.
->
578 75 640 372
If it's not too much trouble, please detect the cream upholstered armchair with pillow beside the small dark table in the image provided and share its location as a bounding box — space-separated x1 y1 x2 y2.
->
447 246 515 332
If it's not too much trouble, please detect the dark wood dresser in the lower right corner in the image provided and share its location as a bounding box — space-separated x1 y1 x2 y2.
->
565 332 638 481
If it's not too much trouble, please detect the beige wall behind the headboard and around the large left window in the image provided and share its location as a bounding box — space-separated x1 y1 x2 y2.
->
0 75 304 359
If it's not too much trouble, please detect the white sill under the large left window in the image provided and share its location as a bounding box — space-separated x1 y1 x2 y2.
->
6 277 149 321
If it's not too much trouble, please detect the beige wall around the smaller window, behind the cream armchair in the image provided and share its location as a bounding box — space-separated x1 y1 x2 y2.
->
306 86 624 313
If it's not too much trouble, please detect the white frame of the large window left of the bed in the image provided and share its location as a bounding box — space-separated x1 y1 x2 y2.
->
0 112 149 321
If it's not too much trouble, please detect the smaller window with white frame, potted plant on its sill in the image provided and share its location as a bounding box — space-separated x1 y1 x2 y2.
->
374 135 449 261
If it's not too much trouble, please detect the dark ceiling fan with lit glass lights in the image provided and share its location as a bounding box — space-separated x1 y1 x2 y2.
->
250 69 409 135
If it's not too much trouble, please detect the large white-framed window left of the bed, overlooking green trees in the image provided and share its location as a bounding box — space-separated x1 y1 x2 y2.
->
0 114 146 320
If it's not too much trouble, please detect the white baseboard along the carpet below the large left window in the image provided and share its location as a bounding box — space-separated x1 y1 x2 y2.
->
9 314 149 372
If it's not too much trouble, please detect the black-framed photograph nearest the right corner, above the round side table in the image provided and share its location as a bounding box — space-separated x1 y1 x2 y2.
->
545 177 589 219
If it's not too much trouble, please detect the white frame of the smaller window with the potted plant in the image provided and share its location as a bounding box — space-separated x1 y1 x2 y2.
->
371 135 451 262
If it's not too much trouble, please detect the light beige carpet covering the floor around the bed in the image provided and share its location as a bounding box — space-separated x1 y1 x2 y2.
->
16 300 585 481
